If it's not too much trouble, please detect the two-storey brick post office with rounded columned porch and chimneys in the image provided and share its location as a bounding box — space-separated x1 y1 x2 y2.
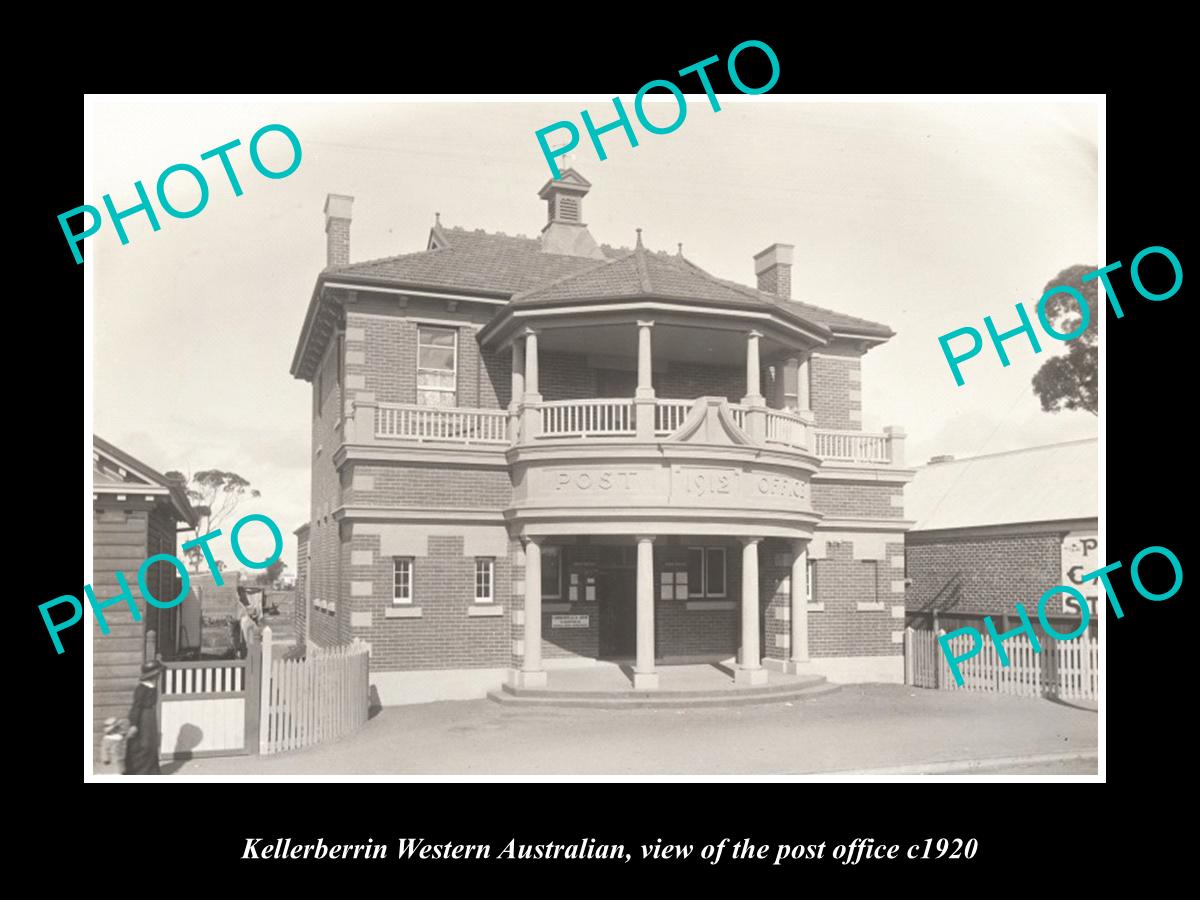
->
292 169 912 703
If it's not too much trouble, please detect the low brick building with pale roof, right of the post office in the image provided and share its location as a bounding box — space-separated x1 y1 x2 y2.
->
905 438 1104 634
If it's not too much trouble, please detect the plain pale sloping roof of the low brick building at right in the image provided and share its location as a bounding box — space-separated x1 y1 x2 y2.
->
904 438 1099 532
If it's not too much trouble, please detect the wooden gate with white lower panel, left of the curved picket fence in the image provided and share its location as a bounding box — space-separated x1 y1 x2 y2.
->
158 644 262 760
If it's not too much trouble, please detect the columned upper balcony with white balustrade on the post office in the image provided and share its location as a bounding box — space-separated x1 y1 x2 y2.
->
344 316 904 468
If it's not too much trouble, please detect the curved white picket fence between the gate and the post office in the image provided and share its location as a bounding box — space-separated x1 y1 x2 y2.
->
259 628 371 754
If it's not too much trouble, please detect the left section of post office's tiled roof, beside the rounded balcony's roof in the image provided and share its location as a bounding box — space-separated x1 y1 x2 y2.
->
325 228 619 294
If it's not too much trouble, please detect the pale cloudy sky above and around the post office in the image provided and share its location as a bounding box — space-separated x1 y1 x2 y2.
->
87 95 1111 569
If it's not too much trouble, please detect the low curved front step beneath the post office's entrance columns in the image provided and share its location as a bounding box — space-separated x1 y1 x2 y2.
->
487 676 841 709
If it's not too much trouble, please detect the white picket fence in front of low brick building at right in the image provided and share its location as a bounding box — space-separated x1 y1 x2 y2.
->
905 628 1100 700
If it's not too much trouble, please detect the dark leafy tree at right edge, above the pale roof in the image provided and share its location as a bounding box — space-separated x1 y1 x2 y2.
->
1033 265 1100 415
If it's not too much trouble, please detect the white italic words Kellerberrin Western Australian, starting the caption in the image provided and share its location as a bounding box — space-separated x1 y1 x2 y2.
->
241 838 631 862
